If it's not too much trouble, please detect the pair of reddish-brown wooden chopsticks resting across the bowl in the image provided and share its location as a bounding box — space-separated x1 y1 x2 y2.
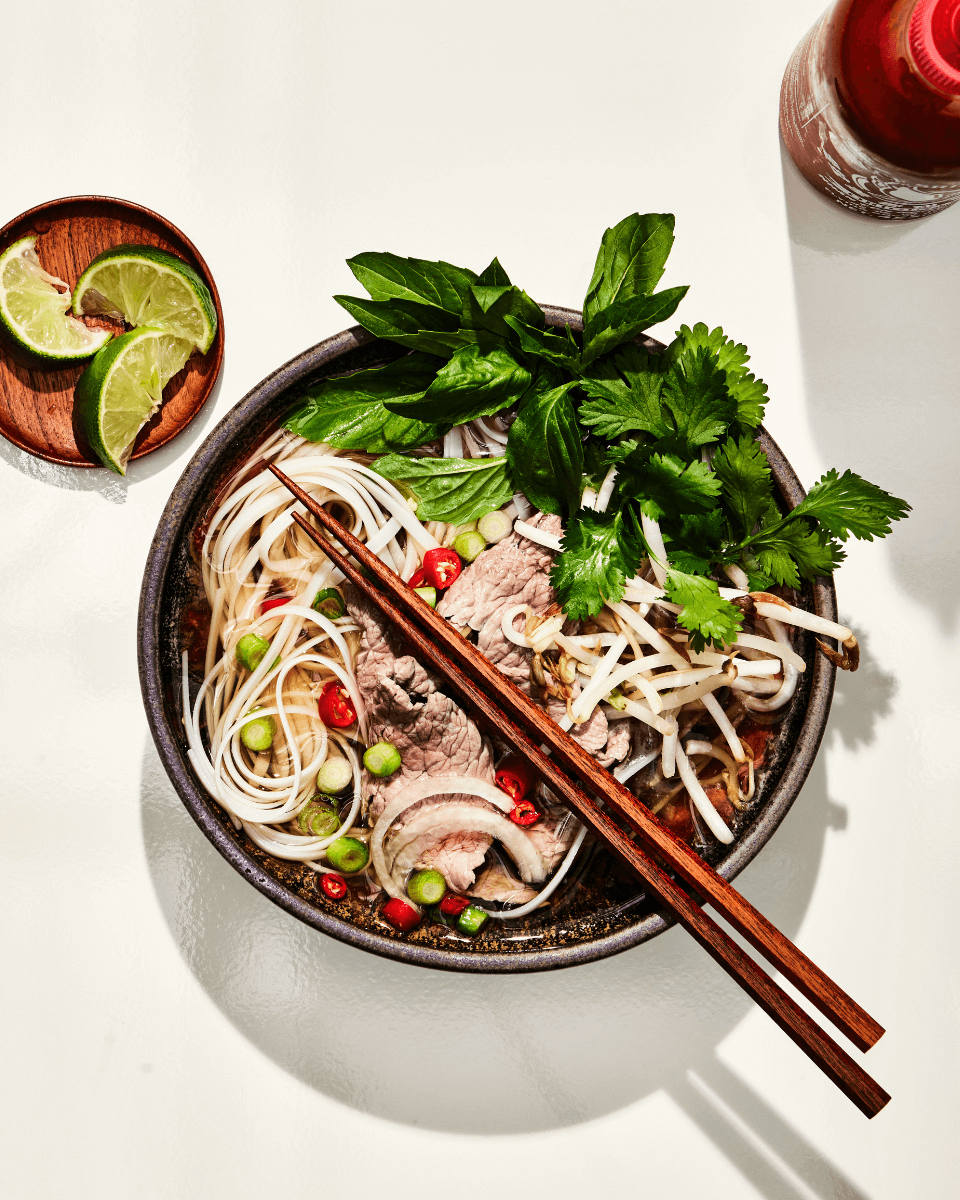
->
270 464 890 1117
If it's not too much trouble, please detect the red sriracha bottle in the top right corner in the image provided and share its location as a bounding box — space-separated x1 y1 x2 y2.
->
780 0 960 221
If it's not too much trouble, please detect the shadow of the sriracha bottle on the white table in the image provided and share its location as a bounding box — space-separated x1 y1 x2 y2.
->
781 146 960 631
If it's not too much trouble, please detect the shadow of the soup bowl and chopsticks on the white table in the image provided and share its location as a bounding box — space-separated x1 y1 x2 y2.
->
142 677 889 1200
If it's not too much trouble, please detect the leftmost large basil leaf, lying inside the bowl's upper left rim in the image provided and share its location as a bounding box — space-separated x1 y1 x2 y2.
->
283 354 450 454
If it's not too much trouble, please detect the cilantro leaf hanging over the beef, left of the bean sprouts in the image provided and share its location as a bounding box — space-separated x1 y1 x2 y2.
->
550 509 643 618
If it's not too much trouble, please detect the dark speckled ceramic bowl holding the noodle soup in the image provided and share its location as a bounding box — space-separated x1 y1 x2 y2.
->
138 307 836 972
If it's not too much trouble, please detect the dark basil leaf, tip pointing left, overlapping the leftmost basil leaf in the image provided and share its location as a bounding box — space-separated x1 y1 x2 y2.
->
384 346 530 425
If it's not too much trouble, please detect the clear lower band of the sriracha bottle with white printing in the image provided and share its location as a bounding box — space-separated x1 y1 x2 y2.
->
780 11 960 221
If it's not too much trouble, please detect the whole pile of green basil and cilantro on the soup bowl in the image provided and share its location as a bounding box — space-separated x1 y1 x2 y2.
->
286 212 910 649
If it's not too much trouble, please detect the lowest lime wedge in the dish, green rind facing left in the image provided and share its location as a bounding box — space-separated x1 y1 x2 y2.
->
73 325 193 475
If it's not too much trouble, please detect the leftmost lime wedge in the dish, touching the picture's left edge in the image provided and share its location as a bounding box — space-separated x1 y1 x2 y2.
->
0 238 112 362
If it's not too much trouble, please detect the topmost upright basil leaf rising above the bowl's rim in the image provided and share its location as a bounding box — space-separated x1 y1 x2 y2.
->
583 212 674 324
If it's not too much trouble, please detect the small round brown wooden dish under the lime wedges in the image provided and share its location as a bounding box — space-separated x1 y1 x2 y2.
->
0 196 223 467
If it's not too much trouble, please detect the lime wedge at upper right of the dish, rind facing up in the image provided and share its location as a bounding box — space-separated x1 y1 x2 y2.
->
73 245 217 354
